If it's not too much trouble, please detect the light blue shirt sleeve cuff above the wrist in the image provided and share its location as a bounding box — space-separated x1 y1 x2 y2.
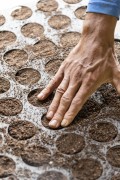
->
87 0 120 19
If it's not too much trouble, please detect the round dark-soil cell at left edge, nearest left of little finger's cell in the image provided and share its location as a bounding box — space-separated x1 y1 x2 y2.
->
0 98 23 116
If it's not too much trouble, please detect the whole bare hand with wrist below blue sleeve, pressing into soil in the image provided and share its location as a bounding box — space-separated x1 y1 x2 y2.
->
38 13 120 129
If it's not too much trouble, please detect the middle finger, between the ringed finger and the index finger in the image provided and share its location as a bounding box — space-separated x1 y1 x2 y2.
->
49 84 80 128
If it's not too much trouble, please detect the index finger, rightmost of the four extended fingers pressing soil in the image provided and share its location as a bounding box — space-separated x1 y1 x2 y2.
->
61 83 94 127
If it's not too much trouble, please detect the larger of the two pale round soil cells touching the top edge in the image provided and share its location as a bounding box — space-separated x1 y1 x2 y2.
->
37 0 58 12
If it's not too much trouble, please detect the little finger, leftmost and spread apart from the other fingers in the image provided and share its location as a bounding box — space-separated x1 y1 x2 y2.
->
38 66 64 100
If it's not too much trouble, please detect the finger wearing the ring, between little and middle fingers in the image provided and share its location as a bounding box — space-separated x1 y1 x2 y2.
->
47 76 69 119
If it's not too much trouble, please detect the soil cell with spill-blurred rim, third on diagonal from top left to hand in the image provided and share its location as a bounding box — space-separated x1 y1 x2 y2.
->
32 40 57 58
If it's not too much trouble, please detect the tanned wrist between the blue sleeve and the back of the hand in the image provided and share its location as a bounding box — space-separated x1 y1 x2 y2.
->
81 13 117 46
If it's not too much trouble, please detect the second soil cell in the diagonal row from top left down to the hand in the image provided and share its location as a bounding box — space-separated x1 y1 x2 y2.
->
21 23 44 38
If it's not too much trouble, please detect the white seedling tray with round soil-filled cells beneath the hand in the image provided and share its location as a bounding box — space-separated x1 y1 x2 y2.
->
0 0 120 180
